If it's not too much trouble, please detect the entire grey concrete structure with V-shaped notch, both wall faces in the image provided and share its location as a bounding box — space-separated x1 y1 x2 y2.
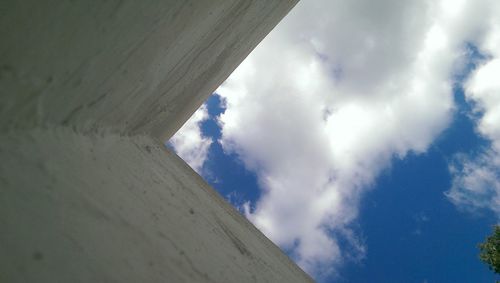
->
0 0 310 282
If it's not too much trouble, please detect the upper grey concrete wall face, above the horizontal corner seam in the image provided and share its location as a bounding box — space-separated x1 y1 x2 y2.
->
0 0 297 139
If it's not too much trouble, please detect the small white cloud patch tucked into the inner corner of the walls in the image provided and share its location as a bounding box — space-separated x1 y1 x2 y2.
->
169 105 212 174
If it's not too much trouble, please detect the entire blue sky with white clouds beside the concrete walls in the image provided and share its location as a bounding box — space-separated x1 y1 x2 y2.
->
168 0 500 282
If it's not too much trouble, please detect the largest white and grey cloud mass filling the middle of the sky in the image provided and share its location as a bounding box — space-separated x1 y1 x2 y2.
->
217 0 499 276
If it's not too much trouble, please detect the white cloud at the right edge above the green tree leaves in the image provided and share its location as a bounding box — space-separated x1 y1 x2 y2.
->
447 7 500 219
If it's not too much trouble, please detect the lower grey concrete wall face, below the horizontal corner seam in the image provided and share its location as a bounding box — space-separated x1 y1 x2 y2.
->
0 128 310 282
